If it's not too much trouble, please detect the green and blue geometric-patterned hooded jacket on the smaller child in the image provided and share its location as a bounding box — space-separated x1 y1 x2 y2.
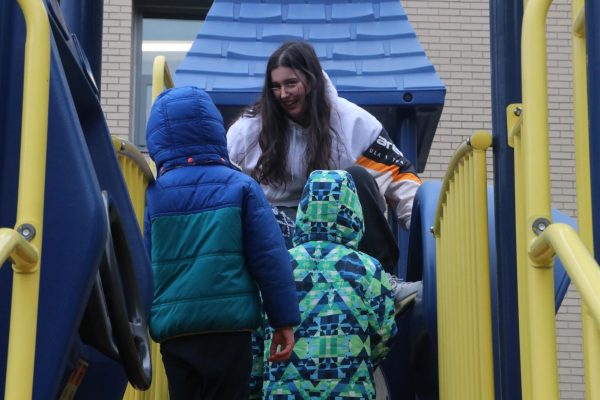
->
263 171 397 399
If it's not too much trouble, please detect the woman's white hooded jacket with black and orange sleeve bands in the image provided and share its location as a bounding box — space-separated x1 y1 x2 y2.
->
227 72 421 228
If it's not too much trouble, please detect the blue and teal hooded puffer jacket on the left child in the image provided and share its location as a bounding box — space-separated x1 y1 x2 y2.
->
144 87 299 342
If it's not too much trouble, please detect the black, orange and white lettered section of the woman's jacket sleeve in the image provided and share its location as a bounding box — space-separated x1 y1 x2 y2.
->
356 129 421 229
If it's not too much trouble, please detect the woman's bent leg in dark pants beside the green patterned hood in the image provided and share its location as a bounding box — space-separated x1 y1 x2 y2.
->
346 166 400 275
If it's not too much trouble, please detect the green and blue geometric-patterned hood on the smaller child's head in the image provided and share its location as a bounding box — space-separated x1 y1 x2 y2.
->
293 170 364 249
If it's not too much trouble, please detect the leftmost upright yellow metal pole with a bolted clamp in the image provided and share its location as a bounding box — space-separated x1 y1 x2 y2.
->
0 0 50 399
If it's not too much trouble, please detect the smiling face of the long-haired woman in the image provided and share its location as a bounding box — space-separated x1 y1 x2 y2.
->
271 67 307 124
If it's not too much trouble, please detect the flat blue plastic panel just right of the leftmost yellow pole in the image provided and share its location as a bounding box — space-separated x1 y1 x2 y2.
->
34 43 108 399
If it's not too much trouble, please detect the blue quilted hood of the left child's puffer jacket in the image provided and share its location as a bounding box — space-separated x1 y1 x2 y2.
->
146 86 230 175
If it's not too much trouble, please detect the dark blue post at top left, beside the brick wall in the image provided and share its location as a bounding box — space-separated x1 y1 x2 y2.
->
60 0 104 92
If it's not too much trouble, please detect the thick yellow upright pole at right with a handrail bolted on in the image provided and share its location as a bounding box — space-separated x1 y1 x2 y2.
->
514 0 559 400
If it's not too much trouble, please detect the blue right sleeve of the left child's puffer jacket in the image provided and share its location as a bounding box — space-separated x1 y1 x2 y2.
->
242 180 300 328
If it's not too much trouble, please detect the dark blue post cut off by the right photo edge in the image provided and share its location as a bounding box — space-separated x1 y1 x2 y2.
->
585 0 600 261
